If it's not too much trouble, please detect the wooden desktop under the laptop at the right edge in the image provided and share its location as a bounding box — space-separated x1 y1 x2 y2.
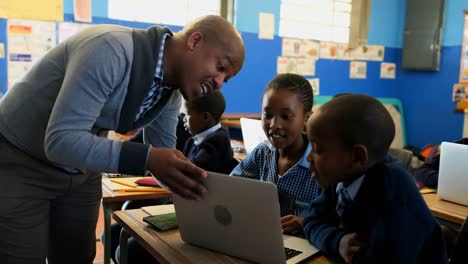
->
423 190 468 225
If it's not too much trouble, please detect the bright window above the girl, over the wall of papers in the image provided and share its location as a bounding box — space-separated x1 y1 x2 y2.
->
279 0 352 43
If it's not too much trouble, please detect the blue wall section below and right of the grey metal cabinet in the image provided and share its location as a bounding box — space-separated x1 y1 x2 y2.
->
397 0 468 146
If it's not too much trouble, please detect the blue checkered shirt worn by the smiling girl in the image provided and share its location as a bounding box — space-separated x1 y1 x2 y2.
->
231 143 321 216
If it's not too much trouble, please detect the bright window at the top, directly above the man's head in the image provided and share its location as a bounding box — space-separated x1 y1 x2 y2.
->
108 0 232 26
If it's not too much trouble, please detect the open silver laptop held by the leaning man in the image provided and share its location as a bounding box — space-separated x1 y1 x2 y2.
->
172 172 319 263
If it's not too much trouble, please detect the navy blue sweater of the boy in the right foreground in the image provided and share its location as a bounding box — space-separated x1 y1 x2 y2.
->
303 156 447 263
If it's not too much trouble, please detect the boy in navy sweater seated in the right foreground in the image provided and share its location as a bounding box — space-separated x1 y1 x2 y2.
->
303 94 447 263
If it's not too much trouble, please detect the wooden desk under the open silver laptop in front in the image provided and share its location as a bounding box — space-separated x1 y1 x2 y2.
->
113 209 331 264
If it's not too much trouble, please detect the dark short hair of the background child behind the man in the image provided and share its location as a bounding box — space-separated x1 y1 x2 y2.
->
185 91 226 122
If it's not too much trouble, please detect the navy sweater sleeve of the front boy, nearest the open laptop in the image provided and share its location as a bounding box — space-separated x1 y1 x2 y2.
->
302 187 345 259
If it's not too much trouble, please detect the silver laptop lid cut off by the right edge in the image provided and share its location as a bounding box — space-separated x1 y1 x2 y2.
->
437 142 468 206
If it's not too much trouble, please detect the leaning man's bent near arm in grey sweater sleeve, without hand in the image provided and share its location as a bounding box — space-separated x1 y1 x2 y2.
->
44 34 132 173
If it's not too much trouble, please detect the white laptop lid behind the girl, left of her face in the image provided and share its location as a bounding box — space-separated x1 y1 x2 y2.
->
240 117 268 154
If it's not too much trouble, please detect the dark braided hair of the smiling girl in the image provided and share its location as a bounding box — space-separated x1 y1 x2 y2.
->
263 73 314 112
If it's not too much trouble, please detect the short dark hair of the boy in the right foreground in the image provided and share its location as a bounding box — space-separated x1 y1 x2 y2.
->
319 94 395 161
